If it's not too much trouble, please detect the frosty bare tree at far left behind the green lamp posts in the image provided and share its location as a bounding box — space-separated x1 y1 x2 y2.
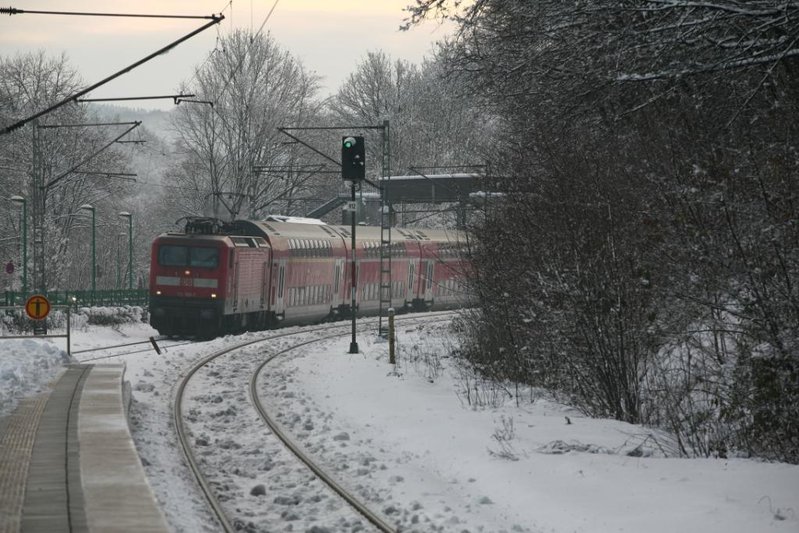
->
0 52 138 289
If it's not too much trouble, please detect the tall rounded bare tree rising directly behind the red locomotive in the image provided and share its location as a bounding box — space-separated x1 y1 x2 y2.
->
173 31 318 218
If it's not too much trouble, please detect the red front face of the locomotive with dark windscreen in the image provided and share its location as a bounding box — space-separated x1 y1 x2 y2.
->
150 233 232 336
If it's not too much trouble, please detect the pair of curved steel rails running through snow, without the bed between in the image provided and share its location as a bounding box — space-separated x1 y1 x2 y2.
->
172 311 454 533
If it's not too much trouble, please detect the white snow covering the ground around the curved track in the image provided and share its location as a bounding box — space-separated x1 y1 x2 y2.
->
0 318 799 533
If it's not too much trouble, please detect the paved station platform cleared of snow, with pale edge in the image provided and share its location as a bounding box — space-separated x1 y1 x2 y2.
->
0 364 169 533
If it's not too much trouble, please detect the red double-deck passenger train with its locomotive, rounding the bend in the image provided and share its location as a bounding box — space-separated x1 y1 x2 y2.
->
150 218 466 337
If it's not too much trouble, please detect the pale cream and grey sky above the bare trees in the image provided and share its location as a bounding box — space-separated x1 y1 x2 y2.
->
0 0 451 109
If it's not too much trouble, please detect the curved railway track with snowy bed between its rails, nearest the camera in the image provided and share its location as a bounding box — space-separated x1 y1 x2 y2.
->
172 312 452 532
